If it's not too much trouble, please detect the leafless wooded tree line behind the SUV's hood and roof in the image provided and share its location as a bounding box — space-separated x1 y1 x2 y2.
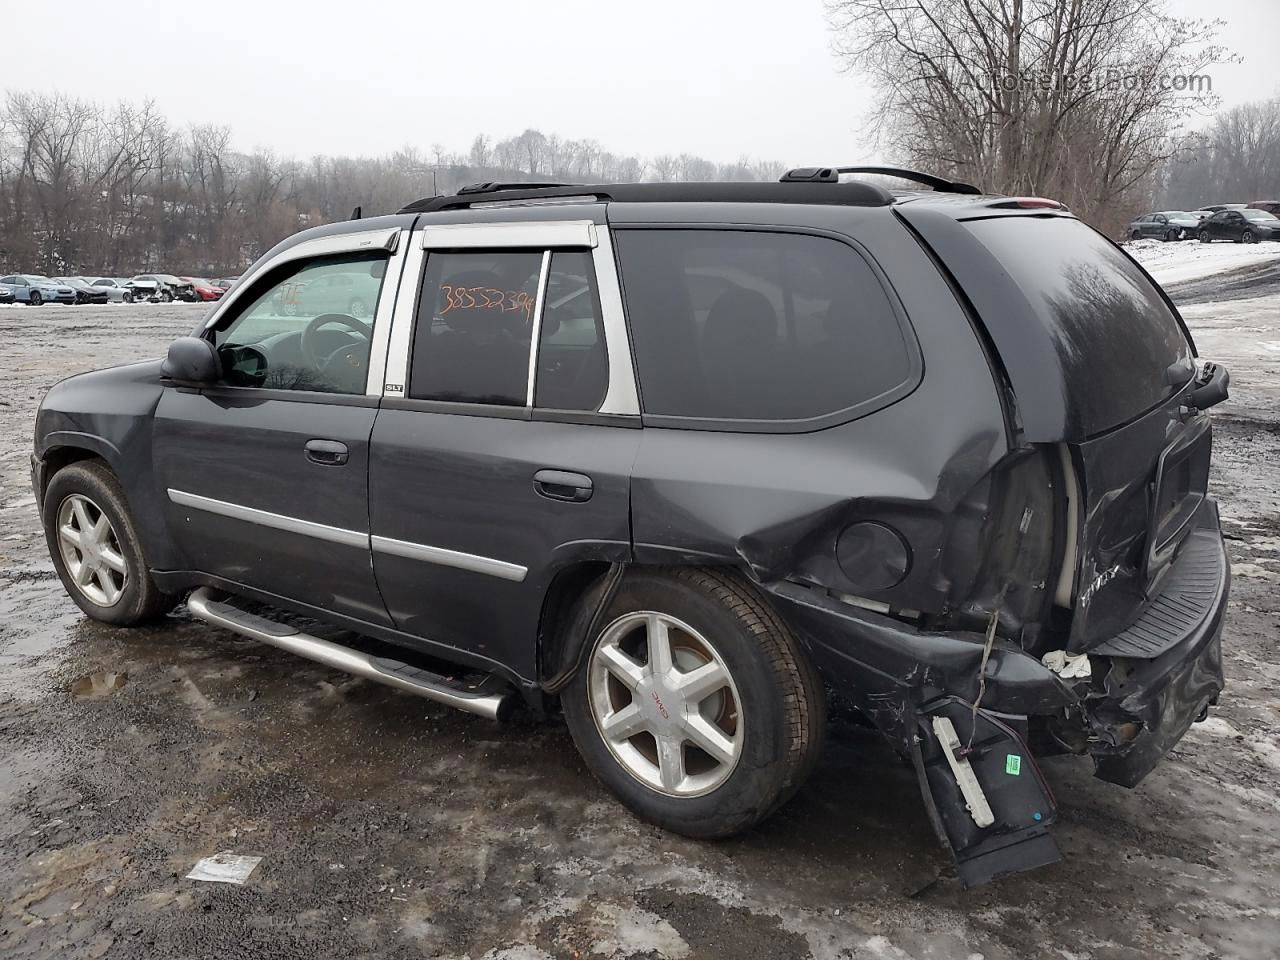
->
0 91 786 275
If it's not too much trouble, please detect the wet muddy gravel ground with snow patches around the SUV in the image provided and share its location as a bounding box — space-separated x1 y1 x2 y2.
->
0 295 1280 960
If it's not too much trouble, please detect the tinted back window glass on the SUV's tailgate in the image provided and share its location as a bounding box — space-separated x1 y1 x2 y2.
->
965 216 1192 435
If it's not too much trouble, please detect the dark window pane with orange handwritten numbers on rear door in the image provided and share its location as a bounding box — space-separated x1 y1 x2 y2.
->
408 250 543 407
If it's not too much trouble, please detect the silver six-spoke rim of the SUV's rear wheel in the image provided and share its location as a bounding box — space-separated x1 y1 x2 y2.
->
588 611 745 797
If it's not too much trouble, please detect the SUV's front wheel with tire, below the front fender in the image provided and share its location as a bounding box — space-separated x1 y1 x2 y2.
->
44 460 179 627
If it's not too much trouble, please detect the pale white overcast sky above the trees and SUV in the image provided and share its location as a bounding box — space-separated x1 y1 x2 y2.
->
0 0 1280 165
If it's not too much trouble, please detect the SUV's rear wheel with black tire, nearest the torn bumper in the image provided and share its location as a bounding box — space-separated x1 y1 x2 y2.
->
562 567 826 840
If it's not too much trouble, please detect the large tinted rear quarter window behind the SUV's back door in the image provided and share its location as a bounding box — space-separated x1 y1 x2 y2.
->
616 229 913 421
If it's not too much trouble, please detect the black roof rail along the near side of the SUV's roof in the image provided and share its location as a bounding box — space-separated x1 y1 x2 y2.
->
399 180 893 214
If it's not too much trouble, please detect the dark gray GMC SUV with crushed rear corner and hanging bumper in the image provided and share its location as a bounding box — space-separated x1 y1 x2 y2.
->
32 168 1229 884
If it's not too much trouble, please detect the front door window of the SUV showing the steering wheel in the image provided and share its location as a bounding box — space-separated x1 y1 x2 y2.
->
214 253 387 394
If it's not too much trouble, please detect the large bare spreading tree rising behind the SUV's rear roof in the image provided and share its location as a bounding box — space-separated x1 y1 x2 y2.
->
827 0 1226 232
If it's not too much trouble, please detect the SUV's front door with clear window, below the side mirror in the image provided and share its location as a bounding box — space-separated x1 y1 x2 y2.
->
155 230 401 625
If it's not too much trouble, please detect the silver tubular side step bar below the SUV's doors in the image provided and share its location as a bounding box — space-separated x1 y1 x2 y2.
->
187 586 512 721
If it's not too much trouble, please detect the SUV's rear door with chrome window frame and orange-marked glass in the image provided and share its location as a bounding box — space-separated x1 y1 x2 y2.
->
370 220 640 678
